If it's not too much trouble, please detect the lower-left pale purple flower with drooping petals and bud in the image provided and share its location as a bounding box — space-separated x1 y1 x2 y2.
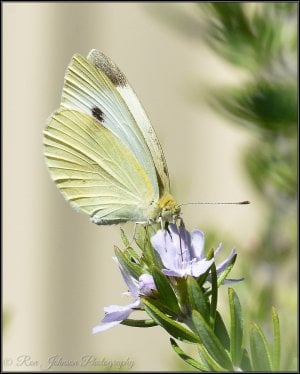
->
92 258 156 334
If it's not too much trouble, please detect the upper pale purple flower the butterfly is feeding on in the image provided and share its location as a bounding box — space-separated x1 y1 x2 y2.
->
151 223 214 278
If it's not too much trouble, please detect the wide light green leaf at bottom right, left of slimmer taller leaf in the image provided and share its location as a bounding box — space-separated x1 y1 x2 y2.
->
249 323 272 371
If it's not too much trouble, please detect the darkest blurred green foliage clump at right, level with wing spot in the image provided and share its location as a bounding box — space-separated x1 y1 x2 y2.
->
211 79 298 136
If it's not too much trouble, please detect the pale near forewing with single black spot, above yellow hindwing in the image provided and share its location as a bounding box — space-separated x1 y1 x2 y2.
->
61 51 164 202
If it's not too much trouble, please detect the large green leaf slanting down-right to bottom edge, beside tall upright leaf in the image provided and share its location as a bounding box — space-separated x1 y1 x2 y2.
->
192 310 233 370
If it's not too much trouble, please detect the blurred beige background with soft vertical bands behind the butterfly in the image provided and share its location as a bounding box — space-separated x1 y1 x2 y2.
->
3 2 264 371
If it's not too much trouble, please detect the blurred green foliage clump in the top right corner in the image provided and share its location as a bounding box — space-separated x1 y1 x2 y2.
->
197 2 297 71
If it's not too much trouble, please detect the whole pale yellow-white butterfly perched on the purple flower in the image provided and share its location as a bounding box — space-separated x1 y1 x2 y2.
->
44 49 180 225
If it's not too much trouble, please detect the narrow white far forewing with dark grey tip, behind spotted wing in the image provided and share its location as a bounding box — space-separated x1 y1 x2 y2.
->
87 49 170 195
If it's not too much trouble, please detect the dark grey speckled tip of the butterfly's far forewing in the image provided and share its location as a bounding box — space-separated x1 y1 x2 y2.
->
88 50 127 87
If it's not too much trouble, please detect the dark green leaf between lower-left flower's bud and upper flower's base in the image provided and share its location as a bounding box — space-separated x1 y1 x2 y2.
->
151 267 180 314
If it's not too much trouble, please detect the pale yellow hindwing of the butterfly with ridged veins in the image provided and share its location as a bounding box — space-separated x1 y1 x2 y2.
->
44 109 158 224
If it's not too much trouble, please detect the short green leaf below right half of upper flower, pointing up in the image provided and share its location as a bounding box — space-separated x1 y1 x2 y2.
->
187 276 209 322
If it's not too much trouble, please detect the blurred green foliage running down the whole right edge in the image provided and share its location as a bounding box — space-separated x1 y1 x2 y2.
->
146 2 298 371
